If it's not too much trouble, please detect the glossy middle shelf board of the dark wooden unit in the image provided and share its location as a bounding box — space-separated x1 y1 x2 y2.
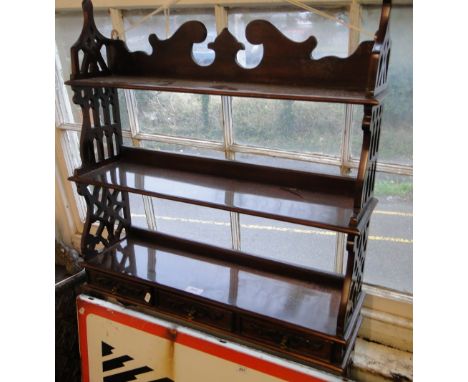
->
70 147 376 234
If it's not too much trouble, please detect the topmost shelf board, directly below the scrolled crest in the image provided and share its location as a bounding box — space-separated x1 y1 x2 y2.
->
66 75 380 105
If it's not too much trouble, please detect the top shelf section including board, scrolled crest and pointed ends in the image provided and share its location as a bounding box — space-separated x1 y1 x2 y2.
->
67 0 391 106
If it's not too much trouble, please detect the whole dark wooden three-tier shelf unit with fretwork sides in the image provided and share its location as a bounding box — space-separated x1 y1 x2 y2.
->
67 0 391 375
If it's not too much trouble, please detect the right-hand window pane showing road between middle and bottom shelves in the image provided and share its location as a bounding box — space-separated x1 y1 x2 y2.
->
240 214 336 272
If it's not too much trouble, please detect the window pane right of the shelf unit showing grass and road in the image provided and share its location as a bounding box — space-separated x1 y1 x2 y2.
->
364 173 413 293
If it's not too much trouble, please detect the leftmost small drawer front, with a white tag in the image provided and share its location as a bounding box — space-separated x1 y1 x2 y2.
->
88 271 154 305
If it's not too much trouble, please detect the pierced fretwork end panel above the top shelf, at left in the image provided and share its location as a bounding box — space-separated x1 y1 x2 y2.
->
71 0 111 79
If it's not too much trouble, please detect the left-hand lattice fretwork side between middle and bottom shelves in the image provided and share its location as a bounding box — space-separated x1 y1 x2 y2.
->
78 184 130 257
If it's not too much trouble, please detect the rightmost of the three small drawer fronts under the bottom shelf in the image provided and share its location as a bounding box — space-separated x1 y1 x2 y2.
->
240 317 333 360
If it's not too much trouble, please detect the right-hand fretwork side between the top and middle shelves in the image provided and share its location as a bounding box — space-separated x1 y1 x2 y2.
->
354 105 383 213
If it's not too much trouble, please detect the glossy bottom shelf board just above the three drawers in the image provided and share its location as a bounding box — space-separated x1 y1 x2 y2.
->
85 228 343 341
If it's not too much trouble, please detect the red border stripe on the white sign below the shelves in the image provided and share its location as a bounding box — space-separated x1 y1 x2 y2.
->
77 297 325 382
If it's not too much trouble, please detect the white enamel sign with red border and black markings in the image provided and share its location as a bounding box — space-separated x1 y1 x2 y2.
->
77 295 341 382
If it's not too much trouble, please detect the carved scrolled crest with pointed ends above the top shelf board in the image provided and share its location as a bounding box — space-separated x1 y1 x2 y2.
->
74 0 390 94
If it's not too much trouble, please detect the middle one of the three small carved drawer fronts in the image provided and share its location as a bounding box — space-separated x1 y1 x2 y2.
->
158 291 232 331
